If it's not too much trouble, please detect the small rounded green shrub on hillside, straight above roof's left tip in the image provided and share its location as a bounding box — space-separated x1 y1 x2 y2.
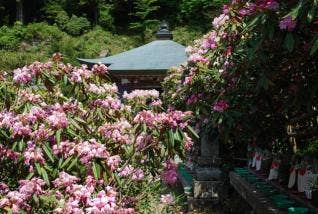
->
65 15 90 36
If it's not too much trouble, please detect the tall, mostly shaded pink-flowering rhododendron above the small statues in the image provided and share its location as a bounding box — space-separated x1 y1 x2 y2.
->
164 0 318 159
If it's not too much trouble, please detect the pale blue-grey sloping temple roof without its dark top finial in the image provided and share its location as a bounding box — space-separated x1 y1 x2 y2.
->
78 40 187 72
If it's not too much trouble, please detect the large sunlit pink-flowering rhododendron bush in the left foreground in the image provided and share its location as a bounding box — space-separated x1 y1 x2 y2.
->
0 57 192 214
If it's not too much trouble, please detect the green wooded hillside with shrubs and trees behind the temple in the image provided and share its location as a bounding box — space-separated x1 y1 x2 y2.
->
0 0 226 71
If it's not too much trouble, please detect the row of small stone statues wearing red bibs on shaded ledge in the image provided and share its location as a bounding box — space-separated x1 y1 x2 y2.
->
248 147 318 199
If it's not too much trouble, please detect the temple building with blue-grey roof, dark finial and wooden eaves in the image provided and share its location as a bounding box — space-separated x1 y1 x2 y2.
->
78 23 187 91
